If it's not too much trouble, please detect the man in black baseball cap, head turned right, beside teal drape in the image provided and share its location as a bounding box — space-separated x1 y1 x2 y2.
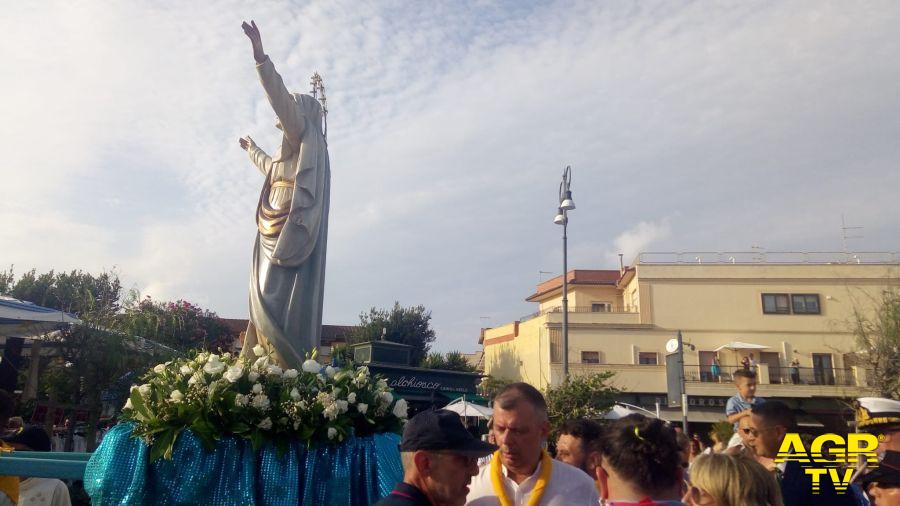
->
377 409 497 506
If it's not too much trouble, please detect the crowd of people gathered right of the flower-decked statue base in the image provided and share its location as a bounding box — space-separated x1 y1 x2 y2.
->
378 378 900 506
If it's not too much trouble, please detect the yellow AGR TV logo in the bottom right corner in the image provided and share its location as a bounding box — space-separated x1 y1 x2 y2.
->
775 432 878 494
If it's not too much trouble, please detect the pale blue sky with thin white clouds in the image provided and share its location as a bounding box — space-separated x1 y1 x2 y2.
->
0 0 900 351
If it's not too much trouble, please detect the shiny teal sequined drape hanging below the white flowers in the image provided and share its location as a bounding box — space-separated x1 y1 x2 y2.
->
84 424 403 506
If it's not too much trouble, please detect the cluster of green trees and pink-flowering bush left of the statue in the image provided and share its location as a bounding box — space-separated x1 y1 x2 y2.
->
0 268 241 448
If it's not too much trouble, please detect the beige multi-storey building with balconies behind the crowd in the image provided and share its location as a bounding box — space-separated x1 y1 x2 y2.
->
480 253 900 422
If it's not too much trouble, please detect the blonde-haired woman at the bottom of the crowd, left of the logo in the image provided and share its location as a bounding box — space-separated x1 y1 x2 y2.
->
682 453 782 506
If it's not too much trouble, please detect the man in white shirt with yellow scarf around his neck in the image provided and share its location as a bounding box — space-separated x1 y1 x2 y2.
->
466 383 600 506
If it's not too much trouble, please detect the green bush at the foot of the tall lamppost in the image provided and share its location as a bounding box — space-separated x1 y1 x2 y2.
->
544 371 621 433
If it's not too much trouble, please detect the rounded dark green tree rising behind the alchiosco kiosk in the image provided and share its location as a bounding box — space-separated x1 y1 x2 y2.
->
348 302 436 364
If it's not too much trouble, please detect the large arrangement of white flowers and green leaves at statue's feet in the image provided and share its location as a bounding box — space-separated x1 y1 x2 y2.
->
121 346 407 461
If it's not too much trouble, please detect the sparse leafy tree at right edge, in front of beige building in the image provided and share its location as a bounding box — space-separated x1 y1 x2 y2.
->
851 289 900 399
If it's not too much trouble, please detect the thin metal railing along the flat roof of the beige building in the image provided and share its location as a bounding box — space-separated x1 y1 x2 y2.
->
637 251 900 265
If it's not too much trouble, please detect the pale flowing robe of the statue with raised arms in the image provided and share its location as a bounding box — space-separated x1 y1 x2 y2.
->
241 58 331 368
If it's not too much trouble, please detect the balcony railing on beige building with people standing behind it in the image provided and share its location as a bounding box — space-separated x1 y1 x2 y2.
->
684 364 856 386
